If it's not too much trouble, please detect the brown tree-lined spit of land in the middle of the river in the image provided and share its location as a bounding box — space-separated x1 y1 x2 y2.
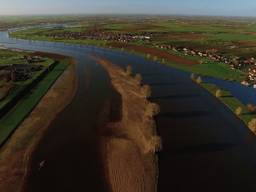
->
95 57 161 192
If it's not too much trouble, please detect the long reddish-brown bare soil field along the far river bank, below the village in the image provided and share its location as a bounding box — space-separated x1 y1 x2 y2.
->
108 42 199 65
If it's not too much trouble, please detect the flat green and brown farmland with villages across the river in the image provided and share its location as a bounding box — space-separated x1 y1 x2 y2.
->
11 16 256 84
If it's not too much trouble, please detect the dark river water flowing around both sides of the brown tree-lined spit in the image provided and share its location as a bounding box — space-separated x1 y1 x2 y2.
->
0 33 256 192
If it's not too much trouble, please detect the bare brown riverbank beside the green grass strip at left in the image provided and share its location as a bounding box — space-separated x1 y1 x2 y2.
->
0 55 76 192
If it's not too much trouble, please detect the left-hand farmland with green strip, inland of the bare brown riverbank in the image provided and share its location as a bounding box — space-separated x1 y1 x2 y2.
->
0 50 67 145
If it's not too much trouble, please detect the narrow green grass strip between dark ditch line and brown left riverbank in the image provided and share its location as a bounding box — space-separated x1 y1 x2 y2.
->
0 61 68 145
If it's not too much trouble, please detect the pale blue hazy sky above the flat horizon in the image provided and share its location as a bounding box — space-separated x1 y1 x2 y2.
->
0 0 256 16
